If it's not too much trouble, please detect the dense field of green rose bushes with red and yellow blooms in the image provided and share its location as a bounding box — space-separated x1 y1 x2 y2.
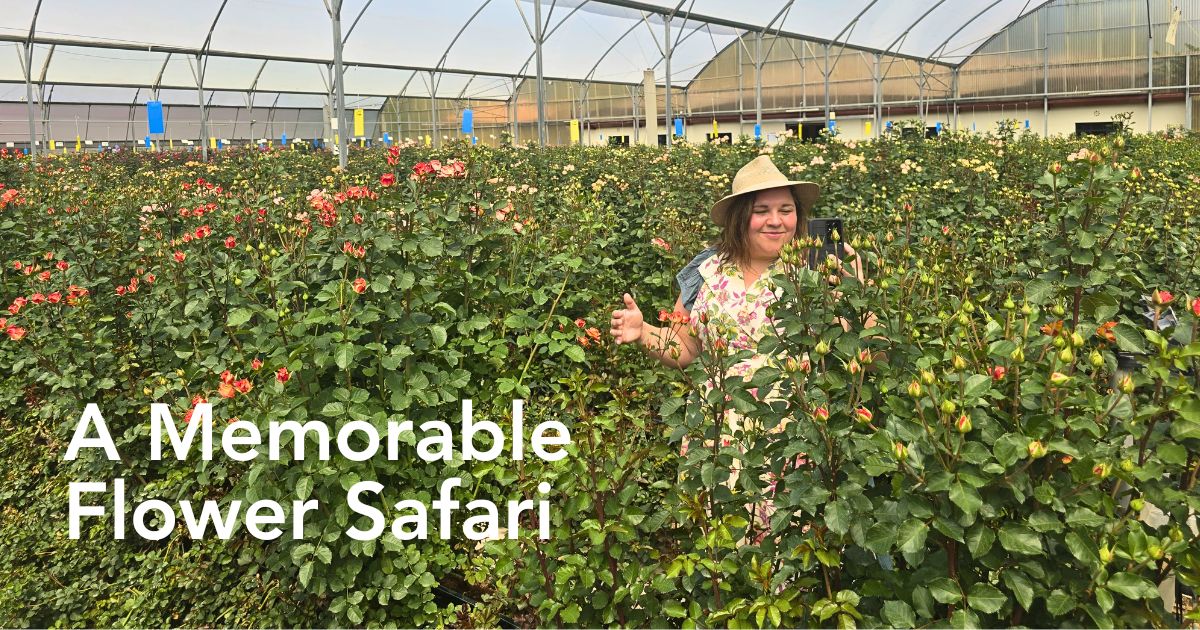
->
0 126 1200 628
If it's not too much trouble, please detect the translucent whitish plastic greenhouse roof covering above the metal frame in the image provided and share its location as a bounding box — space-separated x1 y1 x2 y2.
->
0 0 1045 102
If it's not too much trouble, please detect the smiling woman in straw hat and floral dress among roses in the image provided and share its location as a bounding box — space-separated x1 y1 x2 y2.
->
610 156 872 540
